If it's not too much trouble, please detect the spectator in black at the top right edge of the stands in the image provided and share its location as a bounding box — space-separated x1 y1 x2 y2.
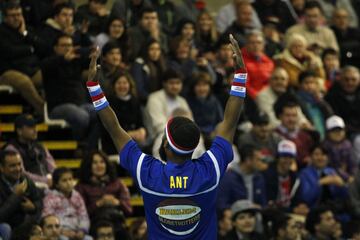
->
331 8 360 66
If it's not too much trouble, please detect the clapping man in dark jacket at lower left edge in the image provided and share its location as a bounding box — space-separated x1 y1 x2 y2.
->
0 150 42 240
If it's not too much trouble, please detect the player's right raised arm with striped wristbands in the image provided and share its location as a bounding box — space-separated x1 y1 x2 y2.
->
217 34 247 143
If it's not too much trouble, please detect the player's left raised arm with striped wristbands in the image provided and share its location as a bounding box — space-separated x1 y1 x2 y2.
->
86 47 131 152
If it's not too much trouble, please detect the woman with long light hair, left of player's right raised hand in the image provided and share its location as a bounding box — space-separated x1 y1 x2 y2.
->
195 11 219 62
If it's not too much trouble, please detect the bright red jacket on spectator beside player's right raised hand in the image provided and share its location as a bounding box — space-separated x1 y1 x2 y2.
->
241 48 275 99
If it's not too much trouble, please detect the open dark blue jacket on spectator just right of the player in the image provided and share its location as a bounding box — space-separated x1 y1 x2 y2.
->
217 169 267 209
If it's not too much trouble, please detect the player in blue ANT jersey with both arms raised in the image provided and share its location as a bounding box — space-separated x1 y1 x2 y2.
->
86 35 247 240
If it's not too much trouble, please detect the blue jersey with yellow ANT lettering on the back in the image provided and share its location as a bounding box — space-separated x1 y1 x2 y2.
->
120 137 233 240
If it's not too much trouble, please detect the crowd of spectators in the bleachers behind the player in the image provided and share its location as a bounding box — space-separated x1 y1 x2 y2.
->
0 0 360 240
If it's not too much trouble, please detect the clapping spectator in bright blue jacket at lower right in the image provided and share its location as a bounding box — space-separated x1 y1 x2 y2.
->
296 145 348 209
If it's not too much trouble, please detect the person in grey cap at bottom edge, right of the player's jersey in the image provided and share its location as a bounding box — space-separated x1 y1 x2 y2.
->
223 200 266 240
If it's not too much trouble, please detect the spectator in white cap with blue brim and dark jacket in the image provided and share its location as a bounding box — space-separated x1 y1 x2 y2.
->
263 140 299 210
